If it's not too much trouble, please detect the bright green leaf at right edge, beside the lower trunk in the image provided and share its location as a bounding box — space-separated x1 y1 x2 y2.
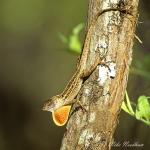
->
136 96 150 122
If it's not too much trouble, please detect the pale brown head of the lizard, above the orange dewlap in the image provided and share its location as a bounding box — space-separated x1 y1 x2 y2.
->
43 95 64 112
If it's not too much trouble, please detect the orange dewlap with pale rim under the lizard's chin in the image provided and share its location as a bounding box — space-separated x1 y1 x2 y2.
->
52 105 71 126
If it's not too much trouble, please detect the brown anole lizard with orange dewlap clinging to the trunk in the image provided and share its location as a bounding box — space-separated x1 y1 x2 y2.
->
43 8 124 126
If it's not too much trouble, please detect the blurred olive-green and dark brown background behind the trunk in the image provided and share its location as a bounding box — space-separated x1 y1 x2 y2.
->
0 0 150 150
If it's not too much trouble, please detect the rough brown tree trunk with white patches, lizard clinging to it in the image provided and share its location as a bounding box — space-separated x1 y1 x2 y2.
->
61 0 138 150
